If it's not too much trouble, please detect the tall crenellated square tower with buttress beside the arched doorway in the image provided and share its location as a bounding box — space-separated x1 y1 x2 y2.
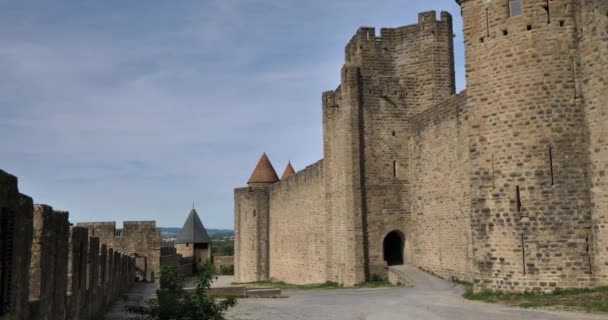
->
323 11 455 284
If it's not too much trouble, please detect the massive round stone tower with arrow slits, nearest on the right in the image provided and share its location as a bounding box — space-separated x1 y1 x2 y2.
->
457 0 592 291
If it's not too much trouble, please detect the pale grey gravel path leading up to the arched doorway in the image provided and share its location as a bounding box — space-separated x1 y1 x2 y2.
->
228 266 608 320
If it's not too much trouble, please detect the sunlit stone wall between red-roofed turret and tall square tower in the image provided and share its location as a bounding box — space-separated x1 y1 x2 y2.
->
269 161 327 284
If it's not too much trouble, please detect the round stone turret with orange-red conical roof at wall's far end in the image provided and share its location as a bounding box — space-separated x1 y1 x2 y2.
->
234 153 279 282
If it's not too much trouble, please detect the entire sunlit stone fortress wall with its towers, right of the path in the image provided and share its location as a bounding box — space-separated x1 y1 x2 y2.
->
235 0 608 291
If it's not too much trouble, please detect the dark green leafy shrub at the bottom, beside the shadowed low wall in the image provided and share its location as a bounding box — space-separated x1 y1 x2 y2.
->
125 267 236 320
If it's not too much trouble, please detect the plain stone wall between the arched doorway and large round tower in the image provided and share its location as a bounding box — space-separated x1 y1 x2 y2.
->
406 92 473 281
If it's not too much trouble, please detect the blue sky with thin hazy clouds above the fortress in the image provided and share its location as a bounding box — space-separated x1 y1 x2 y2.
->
0 0 465 229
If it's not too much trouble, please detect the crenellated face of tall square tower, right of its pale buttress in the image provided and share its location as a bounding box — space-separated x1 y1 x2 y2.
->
346 11 455 275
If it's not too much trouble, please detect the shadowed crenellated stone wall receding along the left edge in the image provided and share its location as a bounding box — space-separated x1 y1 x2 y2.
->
0 170 135 320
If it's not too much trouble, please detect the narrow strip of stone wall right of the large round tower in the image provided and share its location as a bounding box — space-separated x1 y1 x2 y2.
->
577 0 608 285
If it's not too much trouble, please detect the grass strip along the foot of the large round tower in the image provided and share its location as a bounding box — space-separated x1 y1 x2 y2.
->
462 283 608 313
